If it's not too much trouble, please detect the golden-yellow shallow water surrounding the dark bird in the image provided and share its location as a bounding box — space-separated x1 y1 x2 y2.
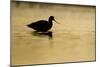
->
12 3 95 65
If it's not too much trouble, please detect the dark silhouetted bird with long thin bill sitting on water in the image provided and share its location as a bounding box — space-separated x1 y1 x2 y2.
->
27 16 58 32
